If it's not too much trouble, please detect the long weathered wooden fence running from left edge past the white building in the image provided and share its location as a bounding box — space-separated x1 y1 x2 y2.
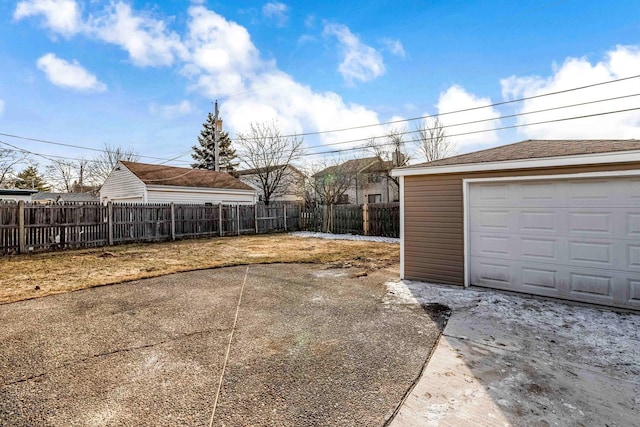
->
0 202 300 255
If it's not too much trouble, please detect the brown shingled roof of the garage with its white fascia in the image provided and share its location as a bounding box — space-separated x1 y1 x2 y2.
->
392 139 640 176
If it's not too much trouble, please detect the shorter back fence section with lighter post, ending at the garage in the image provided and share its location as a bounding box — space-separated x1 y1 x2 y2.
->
300 202 400 237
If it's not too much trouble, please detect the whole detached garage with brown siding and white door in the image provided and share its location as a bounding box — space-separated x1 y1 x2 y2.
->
393 140 640 310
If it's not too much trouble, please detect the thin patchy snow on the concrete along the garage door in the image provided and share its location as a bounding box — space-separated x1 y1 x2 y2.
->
386 280 640 385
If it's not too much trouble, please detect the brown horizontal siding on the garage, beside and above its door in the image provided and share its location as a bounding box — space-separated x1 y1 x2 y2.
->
403 163 640 285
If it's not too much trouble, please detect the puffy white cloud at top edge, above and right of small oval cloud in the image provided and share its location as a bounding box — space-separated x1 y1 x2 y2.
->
87 2 185 67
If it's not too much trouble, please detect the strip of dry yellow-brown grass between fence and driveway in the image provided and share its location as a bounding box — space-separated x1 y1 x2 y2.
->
0 234 400 303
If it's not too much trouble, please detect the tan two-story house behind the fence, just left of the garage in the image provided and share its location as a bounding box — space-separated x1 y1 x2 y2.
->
314 157 400 205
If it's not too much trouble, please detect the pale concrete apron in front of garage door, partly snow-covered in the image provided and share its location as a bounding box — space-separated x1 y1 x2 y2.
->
387 282 640 427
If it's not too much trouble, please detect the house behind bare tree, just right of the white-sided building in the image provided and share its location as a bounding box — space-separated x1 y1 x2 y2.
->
236 165 305 202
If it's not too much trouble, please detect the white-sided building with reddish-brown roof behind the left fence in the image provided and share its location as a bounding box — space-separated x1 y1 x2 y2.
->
100 161 256 204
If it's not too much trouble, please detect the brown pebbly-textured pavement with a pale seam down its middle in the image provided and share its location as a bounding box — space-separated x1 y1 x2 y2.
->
0 265 443 426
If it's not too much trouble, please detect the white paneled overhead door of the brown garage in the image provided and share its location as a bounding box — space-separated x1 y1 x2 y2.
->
468 177 640 309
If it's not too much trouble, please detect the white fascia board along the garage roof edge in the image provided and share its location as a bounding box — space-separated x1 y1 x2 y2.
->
391 150 640 177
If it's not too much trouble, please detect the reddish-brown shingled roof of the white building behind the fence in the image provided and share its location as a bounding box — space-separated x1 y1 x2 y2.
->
120 161 253 191
